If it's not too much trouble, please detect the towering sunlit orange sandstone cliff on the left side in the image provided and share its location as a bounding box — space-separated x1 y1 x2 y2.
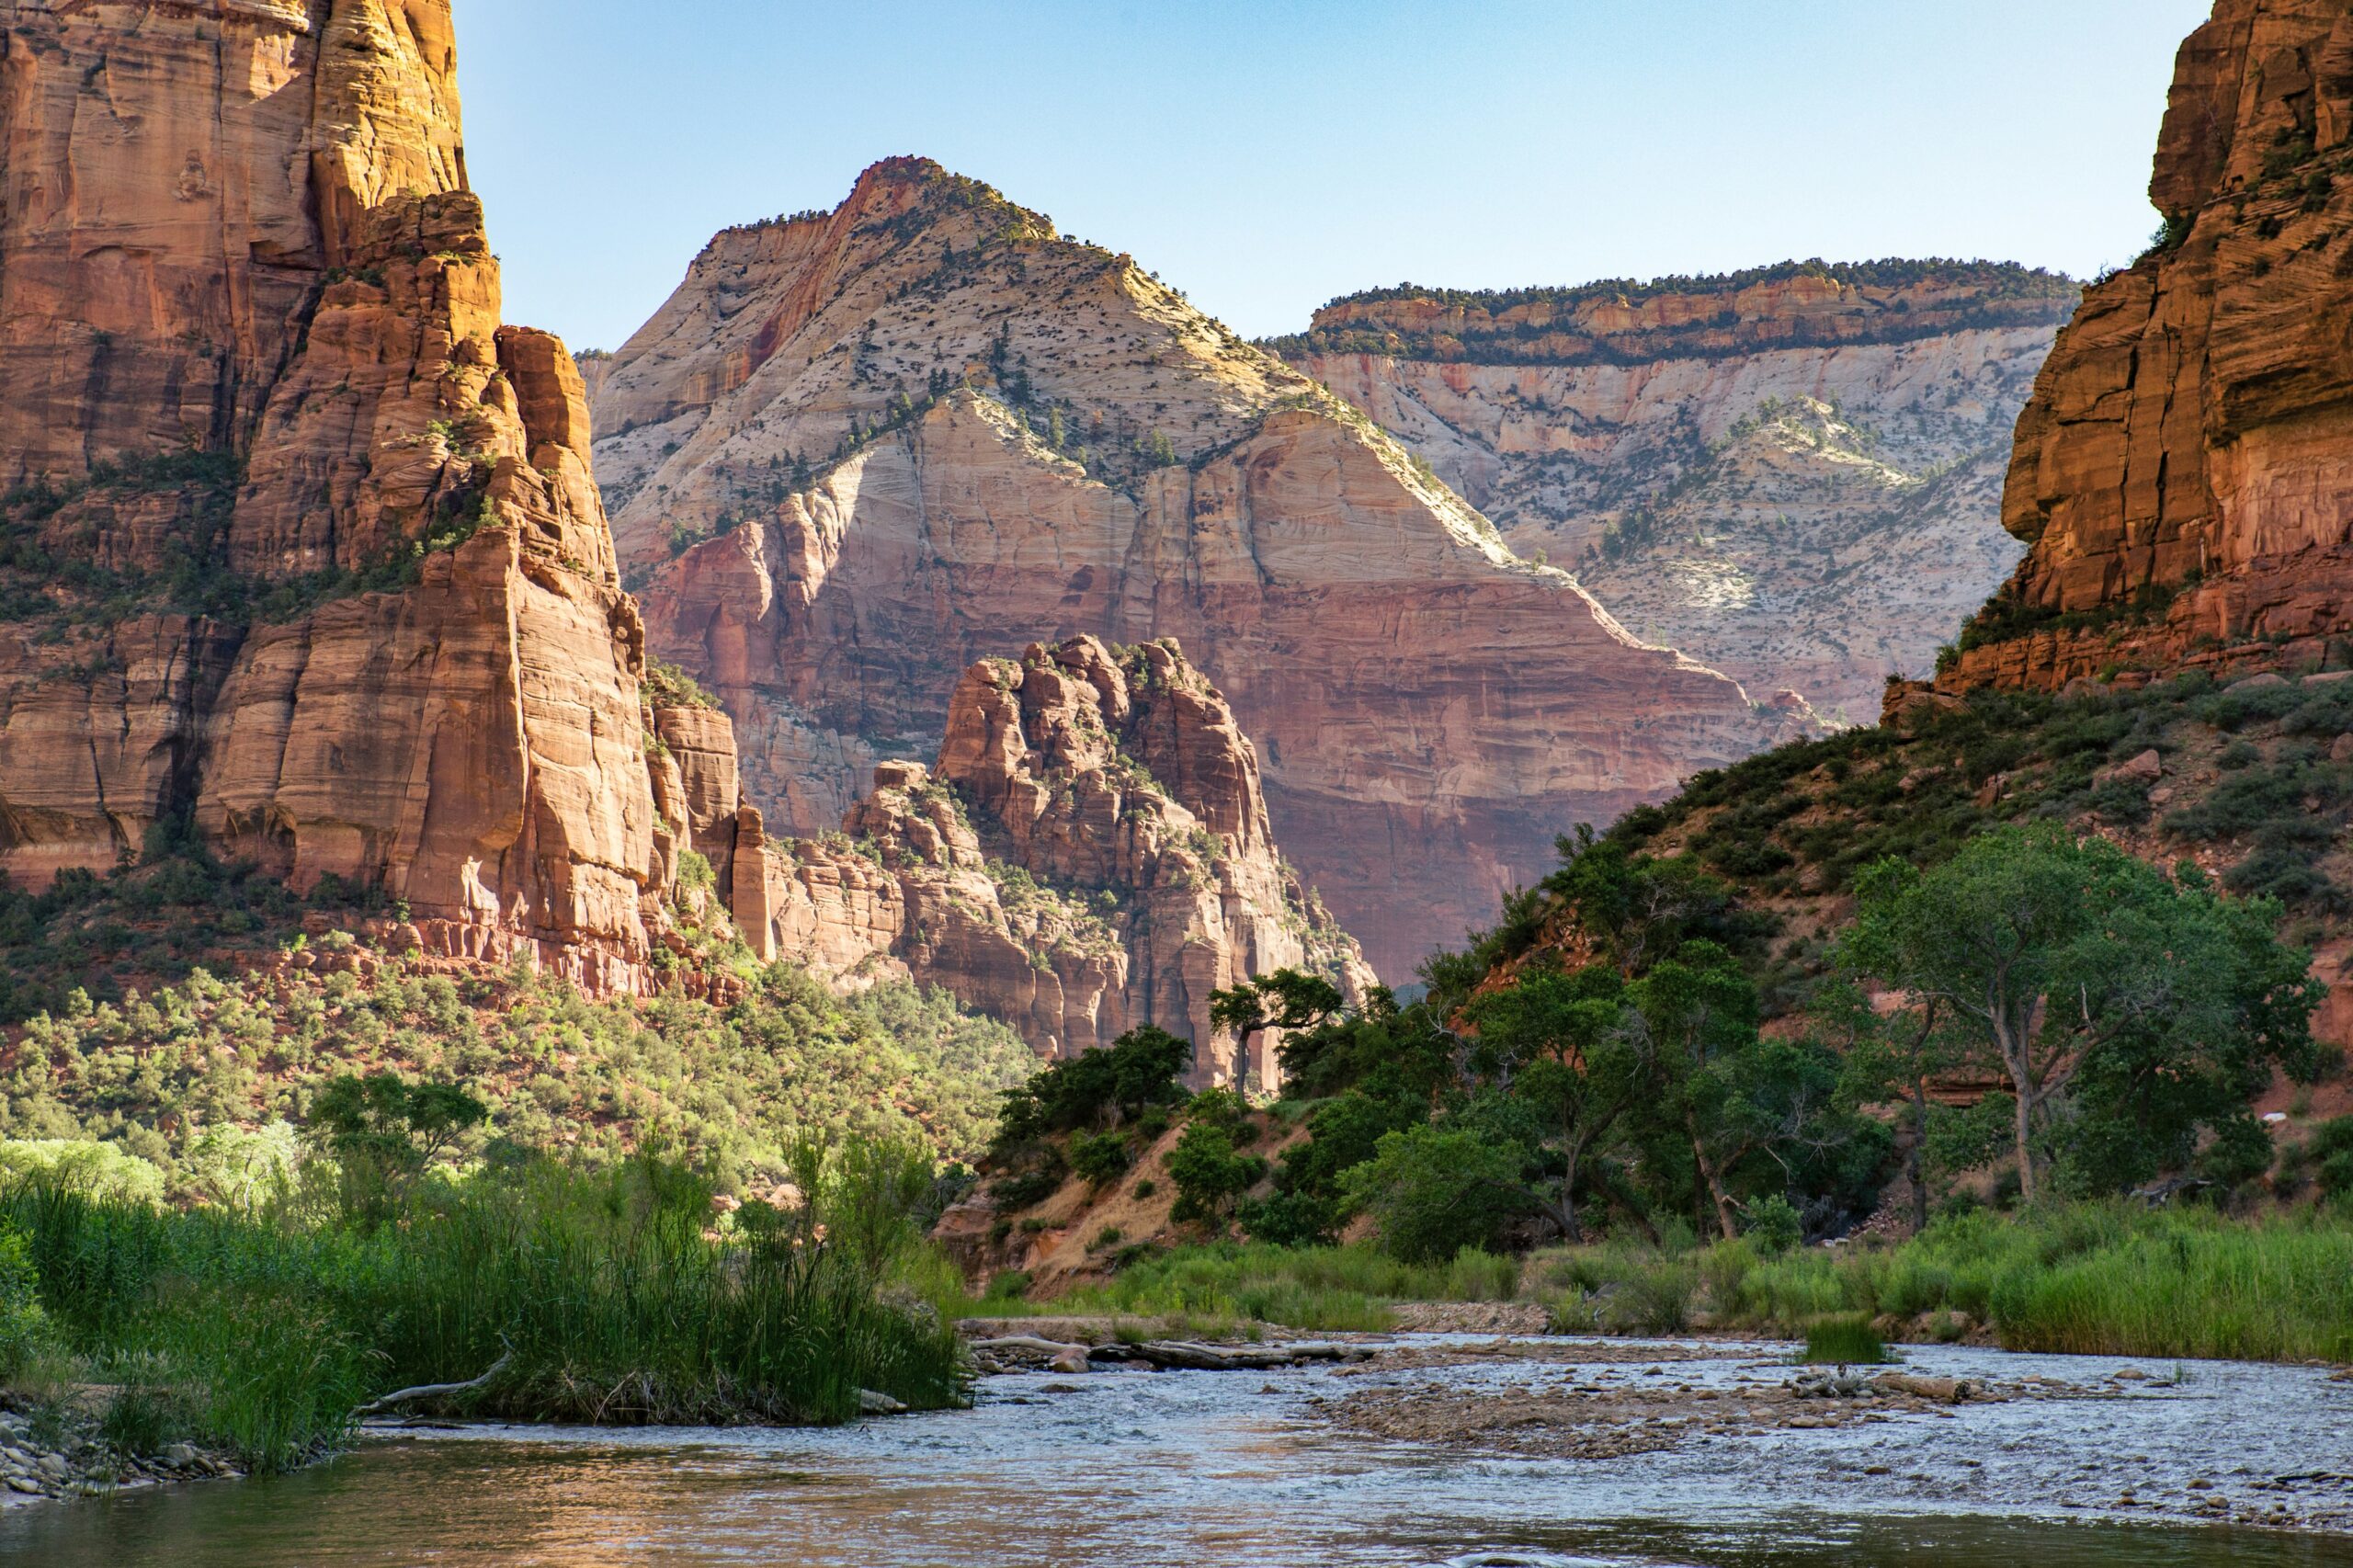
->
0 0 673 986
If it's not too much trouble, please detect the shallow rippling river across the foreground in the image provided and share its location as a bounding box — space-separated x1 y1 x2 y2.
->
0 1342 2353 1568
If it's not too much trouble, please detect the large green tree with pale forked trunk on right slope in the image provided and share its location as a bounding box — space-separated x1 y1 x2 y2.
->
1845 824 2325 1203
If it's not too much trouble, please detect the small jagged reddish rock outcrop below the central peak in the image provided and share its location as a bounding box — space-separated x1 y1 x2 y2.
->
687 638 1374 1085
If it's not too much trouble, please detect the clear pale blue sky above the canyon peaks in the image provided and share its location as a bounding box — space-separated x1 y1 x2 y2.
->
457 0 2210 348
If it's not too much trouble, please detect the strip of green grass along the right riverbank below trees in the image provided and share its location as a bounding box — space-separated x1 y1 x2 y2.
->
1029 1206 2353 1361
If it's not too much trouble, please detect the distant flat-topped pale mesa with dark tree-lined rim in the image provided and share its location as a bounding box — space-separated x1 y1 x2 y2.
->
1268 261 2077 721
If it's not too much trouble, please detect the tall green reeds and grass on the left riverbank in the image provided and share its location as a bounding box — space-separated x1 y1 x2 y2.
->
0 1149 965 1469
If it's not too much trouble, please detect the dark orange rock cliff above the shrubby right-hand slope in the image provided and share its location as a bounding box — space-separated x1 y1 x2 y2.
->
1938 0 2353 690
